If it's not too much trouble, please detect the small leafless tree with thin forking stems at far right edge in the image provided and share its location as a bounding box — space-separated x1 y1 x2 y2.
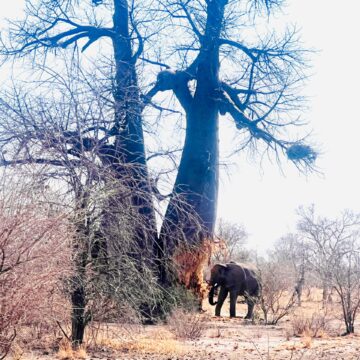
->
298 205 360 304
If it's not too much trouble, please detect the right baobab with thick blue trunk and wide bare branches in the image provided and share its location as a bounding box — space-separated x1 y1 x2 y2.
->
148 0 316 283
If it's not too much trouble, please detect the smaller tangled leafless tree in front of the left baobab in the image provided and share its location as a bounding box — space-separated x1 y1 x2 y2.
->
0 62 167 346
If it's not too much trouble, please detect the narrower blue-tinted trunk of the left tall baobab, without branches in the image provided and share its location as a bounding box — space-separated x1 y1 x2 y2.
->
103 0 157 262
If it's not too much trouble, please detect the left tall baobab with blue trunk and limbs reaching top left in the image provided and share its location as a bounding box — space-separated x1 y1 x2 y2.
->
2 0 156 257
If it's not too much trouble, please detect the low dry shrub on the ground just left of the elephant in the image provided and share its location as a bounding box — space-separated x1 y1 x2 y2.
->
168 309 206 340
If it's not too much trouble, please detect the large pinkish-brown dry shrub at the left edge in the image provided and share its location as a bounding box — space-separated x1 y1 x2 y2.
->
0 195 70 358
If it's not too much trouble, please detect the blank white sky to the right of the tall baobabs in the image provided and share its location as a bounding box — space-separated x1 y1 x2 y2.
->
0 0 360 250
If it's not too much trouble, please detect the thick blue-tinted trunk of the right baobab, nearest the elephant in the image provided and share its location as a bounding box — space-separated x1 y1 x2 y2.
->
160 0 227 290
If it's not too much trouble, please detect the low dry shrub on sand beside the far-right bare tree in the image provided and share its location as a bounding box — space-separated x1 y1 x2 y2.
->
291 313 330 338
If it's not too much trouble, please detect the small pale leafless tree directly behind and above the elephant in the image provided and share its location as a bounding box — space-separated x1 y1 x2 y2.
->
213 219 249 263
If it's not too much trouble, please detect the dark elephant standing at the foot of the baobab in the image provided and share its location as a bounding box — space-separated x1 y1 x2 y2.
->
209 262 261 319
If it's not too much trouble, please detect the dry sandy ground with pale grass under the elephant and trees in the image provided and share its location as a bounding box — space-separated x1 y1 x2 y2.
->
13 294 360 360
